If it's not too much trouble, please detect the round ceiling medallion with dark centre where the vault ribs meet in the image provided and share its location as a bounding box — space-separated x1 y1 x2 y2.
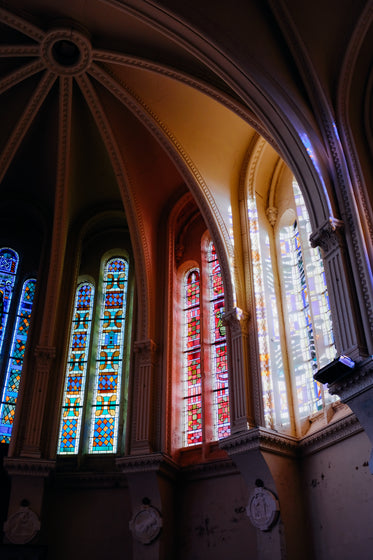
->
41 28 92 76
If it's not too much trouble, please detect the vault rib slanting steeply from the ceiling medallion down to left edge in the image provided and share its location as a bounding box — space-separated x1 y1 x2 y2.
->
0 72 56 183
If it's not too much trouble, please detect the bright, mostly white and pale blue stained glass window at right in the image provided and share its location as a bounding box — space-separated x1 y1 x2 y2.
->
280 182 336 418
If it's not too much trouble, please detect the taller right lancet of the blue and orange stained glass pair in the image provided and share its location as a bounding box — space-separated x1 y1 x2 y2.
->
89 258 128 453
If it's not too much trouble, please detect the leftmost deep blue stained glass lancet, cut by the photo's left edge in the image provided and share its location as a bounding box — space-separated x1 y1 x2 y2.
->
0 248 19 352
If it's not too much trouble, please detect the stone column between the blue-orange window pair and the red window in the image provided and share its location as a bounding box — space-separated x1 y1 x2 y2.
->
131 339 157 455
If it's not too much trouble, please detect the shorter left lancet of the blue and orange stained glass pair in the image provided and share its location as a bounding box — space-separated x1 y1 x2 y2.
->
58 282 94 454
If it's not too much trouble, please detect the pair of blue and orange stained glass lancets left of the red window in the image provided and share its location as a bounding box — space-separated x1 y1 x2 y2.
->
57 257 128 455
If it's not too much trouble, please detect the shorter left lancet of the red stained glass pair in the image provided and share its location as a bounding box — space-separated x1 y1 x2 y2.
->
183 269 202 446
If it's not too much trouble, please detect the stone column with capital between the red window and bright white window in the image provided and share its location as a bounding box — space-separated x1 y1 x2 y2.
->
224 308 255 434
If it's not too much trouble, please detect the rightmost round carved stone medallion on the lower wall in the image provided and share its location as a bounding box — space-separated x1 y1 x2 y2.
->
246 487 280 531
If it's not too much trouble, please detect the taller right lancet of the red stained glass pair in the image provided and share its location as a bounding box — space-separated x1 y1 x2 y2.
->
208 243 230 439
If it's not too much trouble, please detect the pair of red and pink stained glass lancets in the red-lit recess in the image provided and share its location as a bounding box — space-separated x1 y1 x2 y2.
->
183 243 230 446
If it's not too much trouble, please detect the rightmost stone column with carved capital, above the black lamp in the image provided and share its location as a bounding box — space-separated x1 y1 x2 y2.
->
310 218 366 361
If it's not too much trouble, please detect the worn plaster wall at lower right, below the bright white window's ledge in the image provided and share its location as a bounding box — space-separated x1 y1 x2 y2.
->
303 432 373 560
